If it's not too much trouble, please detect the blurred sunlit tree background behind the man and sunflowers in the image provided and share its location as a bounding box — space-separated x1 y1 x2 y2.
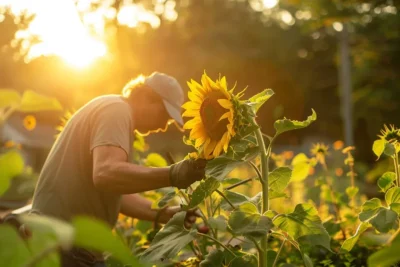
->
0 0 400 209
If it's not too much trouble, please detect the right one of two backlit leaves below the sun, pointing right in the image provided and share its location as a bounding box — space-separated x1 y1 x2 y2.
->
18 90 62 112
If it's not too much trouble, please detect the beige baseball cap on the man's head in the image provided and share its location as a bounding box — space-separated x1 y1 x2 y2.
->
144 72 184 126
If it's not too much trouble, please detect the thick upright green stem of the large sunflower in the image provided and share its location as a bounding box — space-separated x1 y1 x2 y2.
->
256 129 272 267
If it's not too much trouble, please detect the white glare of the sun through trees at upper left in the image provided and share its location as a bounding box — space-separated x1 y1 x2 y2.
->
7 0 107 68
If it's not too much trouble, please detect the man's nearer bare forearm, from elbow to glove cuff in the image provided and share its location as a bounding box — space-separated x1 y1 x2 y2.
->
93 162 171 194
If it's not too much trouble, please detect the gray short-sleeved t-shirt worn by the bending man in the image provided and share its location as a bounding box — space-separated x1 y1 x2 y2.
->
32 95 133 227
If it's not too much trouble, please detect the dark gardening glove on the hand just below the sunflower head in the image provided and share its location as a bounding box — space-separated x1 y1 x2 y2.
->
169 159 207 189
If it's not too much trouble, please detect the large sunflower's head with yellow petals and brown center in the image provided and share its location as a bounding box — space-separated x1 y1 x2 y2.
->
182 73 235 159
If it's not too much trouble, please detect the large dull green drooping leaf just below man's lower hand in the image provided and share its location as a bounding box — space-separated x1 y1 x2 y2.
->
140 211 197 262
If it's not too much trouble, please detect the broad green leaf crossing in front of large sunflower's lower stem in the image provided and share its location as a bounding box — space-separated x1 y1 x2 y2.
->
228 202 272 238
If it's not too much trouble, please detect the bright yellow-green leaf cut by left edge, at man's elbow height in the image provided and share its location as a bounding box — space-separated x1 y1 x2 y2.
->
0 150 24 196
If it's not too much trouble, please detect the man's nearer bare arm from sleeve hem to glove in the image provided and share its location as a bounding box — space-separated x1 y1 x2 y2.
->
93 146 171 194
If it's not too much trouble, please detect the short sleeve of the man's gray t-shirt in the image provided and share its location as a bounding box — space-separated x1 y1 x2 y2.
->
90 103 133 156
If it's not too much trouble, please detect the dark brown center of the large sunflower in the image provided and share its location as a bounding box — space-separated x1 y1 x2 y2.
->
200 92 229 140
